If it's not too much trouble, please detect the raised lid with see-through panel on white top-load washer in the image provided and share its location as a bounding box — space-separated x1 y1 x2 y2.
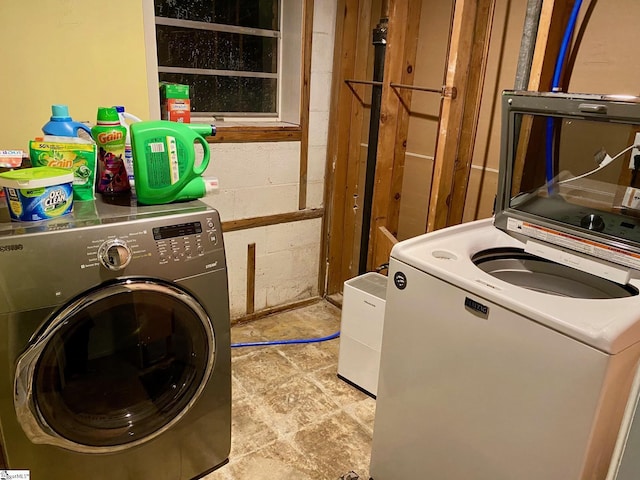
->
495 91 640 270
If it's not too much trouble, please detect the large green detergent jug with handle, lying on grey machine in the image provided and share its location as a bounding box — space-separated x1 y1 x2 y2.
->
129 120 215 205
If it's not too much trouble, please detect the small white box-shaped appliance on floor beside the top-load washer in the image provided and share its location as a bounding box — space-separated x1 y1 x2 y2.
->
338 272 387 396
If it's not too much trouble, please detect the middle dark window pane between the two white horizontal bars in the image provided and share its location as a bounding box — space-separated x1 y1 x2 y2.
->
156 25 278 73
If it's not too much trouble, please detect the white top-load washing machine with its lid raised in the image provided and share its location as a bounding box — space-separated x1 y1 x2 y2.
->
370 92 640 480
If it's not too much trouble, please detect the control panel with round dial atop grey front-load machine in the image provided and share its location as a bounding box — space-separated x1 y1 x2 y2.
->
0 202 226 311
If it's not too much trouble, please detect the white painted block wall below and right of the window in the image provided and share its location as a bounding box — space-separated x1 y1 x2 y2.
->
204 0 336 318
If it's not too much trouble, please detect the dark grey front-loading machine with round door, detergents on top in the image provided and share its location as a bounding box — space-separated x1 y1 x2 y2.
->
0 200 231 480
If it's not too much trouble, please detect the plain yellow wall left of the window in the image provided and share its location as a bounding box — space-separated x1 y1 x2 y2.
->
0 0 149 150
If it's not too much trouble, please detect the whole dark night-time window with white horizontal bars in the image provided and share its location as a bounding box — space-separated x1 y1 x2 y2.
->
148 0 302 123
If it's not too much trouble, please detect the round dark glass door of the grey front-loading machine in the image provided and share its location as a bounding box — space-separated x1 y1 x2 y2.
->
14 279 215 453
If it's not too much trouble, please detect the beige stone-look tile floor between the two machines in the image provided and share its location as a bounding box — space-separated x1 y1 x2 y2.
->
204 301 375 480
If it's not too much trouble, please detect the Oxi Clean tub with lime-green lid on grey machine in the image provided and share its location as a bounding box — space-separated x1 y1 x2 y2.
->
0 167 73 222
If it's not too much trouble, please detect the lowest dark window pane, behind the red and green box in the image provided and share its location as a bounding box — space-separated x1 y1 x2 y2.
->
160 73 277 114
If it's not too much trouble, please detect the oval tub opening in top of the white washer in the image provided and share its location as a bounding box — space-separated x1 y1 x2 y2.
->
472 248 638 299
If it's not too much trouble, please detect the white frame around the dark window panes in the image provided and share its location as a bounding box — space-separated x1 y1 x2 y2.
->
142 0 304 129
